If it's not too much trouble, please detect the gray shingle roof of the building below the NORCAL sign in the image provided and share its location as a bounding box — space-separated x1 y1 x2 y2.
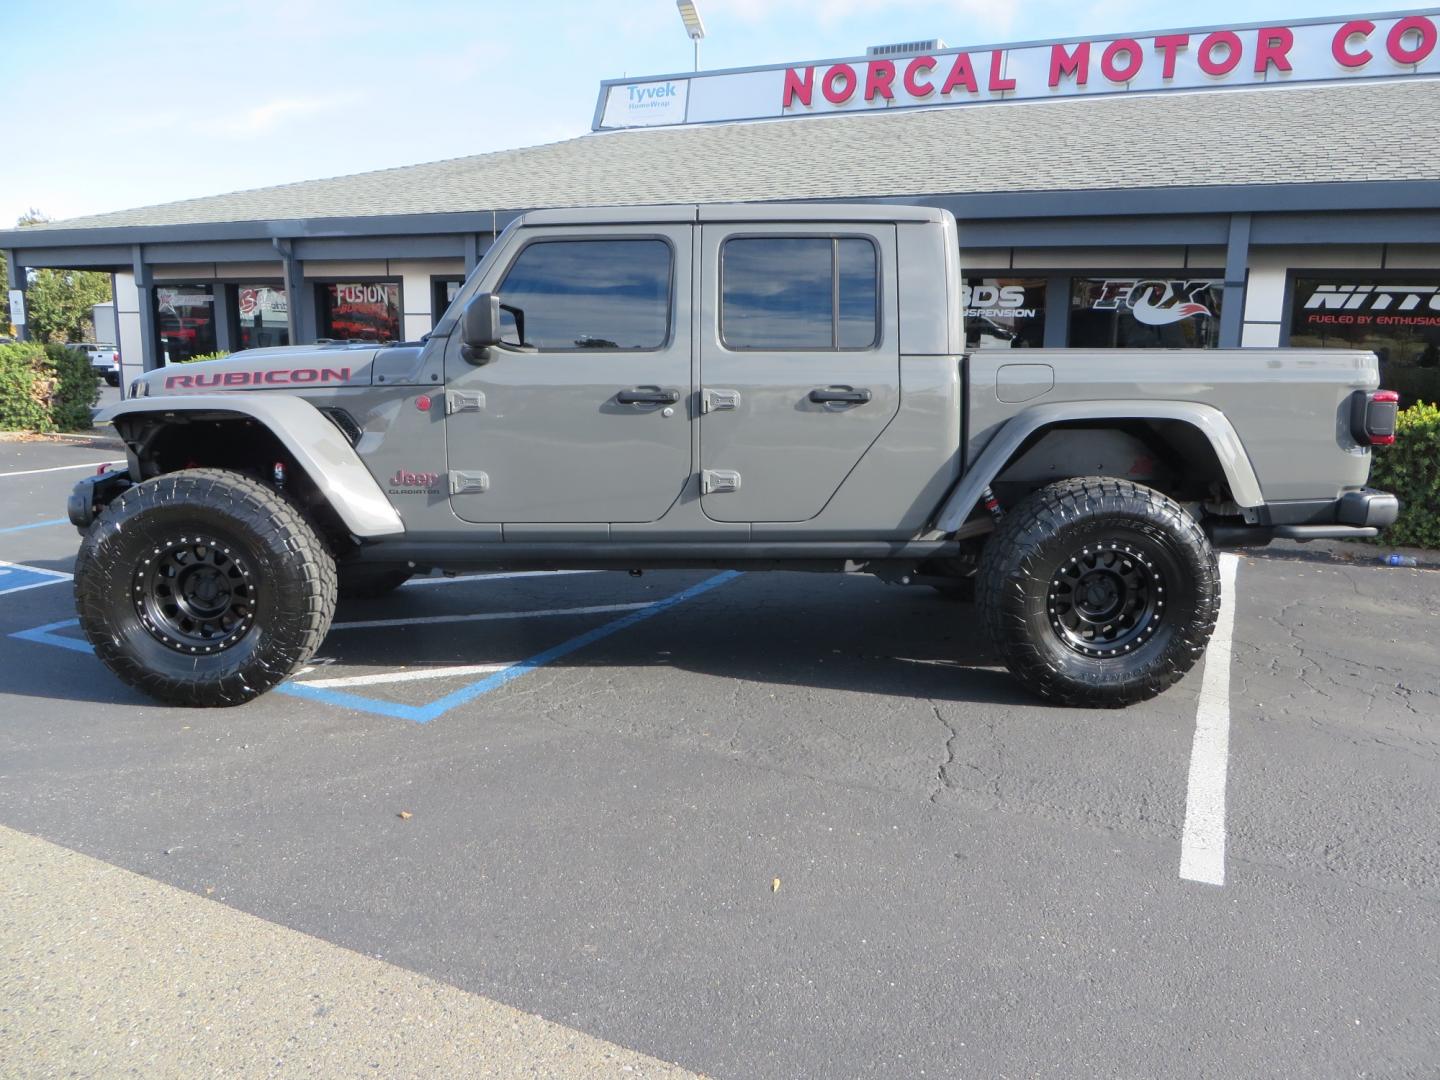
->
22 79 1440 229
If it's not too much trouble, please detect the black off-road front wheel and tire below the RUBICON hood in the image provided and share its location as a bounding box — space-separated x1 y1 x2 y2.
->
75 469 336 706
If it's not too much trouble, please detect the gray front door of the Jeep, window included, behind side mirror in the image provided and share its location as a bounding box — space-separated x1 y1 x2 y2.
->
445 225 693 523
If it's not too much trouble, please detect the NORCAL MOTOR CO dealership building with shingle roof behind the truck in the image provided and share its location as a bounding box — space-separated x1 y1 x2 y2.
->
0 10 1440 397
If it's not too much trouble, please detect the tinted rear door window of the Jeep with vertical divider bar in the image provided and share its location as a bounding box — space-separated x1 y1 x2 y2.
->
720 236 880 348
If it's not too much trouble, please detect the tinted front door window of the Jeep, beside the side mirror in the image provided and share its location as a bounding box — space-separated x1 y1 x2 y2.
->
498 239 671 351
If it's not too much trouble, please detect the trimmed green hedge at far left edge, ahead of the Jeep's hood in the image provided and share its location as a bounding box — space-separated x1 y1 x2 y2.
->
0 341 99 432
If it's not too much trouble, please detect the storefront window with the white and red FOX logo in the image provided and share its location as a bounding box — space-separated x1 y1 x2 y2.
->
1070 276 1224 348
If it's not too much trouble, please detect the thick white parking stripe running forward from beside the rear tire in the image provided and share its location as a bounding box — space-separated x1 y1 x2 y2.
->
1179 552 1240 886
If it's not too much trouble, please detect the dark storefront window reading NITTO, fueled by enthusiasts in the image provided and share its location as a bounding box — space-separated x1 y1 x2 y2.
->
1290 272 1440 405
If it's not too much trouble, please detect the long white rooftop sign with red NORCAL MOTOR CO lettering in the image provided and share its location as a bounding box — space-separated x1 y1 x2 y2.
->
595 10 1440 130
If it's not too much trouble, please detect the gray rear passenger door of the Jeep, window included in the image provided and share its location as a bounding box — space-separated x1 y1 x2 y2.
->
700 223 900 521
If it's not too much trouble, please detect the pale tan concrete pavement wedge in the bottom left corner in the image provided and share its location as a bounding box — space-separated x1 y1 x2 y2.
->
0 827 696 1080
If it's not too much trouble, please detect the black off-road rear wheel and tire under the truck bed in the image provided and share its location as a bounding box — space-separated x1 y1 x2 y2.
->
978 477 1220 708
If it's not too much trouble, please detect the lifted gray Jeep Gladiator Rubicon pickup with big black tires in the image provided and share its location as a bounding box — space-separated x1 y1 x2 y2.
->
69 204 1398 707
